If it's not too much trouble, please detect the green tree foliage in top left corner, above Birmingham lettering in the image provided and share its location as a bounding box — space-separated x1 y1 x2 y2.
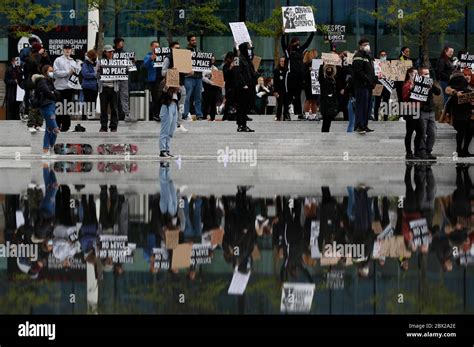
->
0 0 62 37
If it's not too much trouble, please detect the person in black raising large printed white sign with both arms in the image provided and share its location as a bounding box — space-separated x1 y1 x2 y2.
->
281 32 314 120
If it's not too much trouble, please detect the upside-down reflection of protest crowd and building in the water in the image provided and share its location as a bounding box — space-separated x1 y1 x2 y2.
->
0 165 474 314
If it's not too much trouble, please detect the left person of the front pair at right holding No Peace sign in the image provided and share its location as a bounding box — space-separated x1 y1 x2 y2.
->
403 68 423 160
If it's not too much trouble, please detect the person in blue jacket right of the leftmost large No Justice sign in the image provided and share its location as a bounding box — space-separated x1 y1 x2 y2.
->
143 41 162 121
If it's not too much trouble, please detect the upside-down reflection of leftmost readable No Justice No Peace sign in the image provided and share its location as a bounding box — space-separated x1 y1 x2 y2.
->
99 235 133 263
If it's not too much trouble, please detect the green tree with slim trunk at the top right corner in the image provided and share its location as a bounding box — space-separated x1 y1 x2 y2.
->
371 0 473 66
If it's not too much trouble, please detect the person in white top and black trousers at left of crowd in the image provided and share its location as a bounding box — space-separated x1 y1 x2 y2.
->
53 44 76 132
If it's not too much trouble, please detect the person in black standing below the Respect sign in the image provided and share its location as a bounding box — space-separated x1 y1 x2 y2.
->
319 64 339 133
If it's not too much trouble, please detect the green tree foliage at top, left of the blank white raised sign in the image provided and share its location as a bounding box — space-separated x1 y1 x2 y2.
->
131 0 228 42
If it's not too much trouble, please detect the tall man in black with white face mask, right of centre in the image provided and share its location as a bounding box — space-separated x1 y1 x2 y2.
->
352 39 377 134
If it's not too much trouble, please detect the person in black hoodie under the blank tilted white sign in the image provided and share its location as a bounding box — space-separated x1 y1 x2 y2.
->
232 42 256 132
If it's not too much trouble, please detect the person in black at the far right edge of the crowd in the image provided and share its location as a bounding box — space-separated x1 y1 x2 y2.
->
445 69 474 158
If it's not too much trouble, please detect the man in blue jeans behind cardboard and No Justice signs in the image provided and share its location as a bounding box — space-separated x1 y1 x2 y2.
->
183 35 203 120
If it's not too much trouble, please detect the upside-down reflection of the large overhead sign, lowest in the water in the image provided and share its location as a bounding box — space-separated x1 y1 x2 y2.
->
280 283 315 313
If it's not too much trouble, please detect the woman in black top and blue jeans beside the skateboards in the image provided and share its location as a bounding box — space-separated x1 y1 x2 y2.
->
32 65 60 157
